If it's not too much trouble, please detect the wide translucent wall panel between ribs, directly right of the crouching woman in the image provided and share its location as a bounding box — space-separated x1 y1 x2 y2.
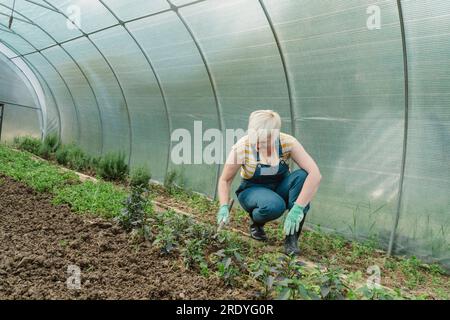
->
263 0 405 245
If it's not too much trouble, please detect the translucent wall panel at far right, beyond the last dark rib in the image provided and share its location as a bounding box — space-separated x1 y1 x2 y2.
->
397 1 450 266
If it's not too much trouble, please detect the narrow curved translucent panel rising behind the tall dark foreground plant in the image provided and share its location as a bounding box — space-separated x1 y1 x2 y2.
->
91 27 170 180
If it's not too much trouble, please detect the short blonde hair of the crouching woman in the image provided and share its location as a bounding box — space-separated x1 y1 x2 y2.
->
248 110 281 143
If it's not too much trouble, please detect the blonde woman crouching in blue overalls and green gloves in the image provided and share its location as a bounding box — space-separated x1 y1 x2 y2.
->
217 110 322 255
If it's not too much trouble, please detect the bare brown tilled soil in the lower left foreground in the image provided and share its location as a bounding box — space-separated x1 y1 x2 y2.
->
0 176 251 299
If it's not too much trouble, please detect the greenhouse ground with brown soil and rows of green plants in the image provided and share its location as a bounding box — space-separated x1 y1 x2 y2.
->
0 144 450 300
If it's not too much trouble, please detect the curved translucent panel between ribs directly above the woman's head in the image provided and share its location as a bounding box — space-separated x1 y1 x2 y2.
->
180 0 291 133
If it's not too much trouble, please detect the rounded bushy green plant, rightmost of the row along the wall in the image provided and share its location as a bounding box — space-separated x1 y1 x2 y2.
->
97 152 128 181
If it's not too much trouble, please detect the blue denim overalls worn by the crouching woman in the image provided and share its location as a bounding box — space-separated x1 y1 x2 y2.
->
236 138 310 225
